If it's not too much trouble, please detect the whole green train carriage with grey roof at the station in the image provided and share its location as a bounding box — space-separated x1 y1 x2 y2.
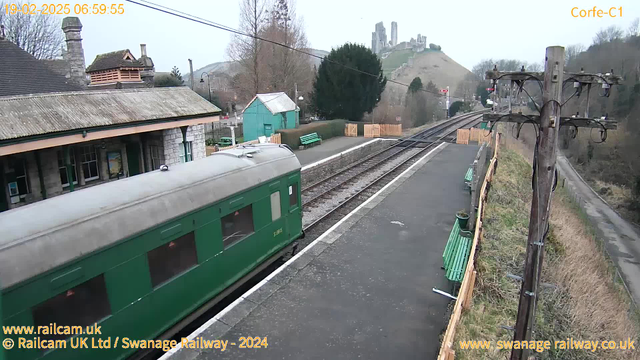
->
0 145 303 360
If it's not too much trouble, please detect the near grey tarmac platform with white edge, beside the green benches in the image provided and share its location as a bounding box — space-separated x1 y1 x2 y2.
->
162 143 478 360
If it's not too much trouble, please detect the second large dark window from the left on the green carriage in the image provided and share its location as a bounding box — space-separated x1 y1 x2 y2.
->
147 231 198 288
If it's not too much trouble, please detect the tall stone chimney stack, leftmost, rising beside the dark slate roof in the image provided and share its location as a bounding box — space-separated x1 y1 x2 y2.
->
62 17 87 88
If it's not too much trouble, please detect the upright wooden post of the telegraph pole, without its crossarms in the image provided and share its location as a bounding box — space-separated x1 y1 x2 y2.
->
511 46 564 360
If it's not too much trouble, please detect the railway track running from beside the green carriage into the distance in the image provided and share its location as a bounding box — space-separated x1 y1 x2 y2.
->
136 112 482 360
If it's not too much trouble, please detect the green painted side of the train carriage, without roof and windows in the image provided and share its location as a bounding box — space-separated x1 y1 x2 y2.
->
0 169 302 360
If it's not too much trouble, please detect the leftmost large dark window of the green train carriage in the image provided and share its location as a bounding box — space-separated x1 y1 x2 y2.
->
31 274 111 340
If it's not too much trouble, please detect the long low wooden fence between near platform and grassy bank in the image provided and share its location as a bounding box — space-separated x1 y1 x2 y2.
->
438 134 500 360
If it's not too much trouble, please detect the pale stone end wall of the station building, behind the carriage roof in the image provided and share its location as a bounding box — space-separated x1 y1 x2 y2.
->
162 124 206 165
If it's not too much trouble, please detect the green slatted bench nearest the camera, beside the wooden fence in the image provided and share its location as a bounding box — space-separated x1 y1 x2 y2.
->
442 219 473 283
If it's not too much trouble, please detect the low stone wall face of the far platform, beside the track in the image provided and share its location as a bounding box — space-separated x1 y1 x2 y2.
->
302 139 396 188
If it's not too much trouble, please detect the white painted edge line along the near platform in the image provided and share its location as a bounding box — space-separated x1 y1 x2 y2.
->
158 139 446 360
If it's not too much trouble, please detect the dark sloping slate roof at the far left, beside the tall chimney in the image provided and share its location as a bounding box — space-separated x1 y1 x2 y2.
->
0 39 81 96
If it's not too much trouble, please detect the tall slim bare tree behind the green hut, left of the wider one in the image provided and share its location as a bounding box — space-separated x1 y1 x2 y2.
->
227 0 266 96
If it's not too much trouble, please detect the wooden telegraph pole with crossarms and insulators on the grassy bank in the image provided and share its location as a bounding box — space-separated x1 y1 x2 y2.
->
484 46 622 360
